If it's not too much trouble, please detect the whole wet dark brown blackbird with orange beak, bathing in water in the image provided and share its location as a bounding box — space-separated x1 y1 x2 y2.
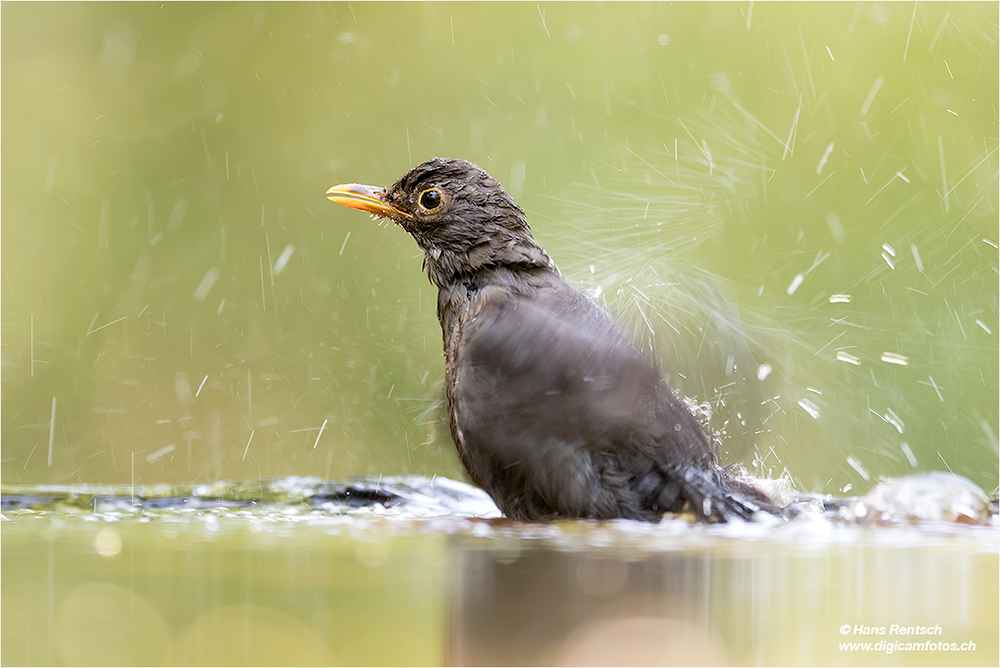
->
327 158 775 521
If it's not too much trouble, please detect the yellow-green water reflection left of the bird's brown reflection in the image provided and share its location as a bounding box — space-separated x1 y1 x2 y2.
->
0 509 449 666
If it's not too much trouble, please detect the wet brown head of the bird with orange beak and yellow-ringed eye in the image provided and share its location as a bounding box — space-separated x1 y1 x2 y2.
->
326 158 551 286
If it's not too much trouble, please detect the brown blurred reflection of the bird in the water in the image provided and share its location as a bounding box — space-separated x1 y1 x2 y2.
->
446 548 730 666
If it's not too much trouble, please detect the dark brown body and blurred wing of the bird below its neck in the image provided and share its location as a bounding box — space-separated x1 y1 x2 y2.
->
440 268 772 520
